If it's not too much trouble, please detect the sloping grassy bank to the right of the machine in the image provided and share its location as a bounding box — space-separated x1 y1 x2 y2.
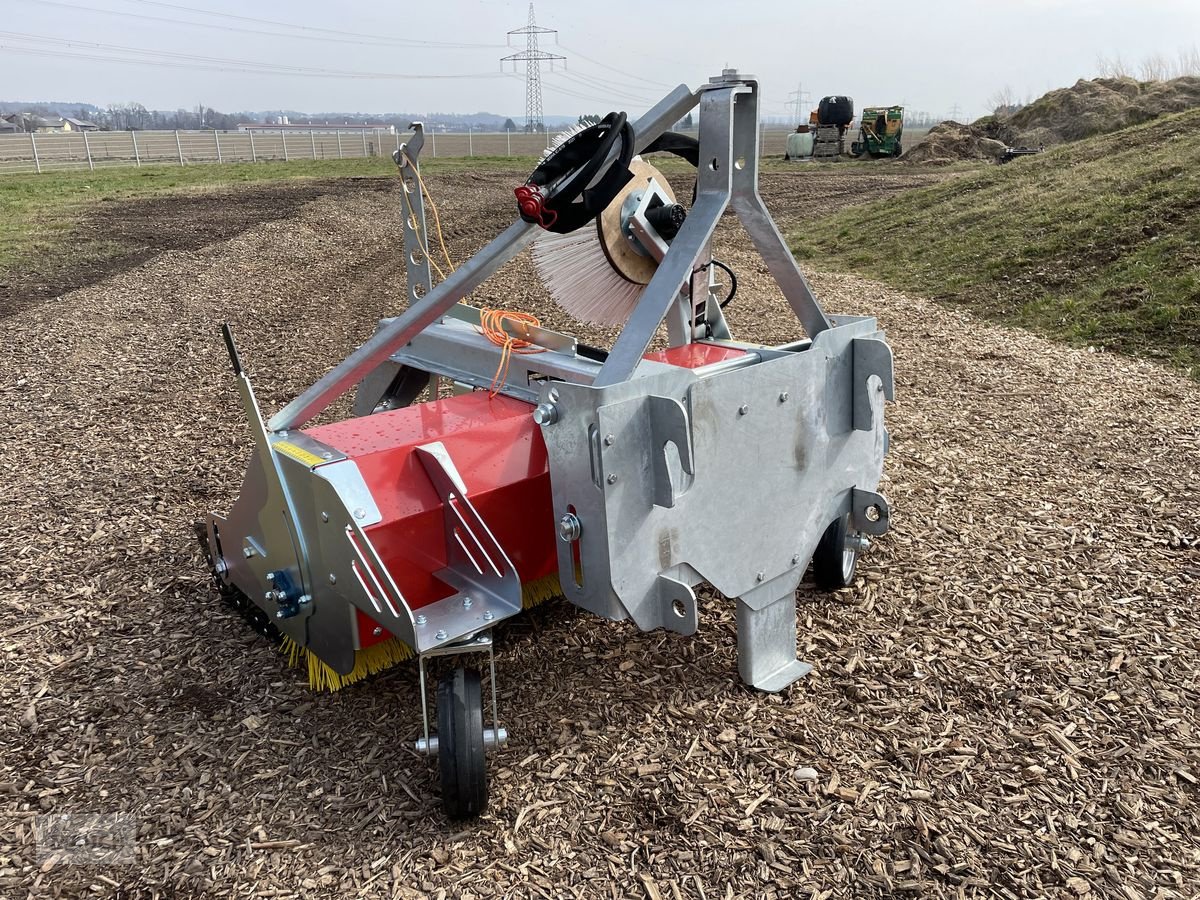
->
792 110 1200 378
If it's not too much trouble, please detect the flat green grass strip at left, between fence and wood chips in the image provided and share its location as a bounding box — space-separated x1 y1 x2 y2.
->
0 156 533 278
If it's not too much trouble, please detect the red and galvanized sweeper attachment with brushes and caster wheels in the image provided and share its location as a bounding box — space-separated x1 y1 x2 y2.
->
205 70 893 817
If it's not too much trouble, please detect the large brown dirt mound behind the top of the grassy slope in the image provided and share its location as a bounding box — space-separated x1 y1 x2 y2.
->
1007 76 1200 145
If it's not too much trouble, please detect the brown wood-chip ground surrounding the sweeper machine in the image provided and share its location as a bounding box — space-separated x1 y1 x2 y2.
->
0 169 1200 900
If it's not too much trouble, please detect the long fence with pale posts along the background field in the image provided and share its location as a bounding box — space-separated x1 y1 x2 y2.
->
0 130 801 174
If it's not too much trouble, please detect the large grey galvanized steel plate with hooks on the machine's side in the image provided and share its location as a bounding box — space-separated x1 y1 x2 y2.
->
542 319 890 628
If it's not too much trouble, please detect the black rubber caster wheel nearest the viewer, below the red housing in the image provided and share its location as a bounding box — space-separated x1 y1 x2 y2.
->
438 668 487 818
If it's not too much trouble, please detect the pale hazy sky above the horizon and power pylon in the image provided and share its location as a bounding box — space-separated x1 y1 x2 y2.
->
7 0 1200 119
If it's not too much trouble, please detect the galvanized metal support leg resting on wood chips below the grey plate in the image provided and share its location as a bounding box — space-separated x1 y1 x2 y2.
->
737 578 812 694
